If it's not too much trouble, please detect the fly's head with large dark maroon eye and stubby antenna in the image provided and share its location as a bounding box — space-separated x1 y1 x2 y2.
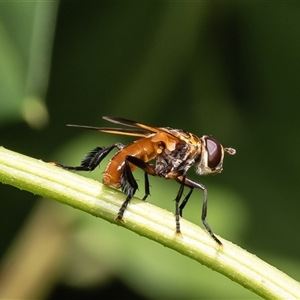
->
196 135 236 175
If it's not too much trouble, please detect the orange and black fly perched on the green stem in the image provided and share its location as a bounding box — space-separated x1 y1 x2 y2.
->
56 117 236 245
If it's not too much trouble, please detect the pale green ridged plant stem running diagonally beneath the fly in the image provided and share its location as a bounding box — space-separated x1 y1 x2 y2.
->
0 147 300 300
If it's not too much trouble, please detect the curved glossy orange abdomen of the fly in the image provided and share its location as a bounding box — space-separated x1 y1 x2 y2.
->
102 137 160 188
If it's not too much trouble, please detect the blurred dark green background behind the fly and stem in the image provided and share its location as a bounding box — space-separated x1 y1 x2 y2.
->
0 1 300 299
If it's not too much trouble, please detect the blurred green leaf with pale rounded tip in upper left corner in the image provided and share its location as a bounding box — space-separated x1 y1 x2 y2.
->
0 1 58 128
